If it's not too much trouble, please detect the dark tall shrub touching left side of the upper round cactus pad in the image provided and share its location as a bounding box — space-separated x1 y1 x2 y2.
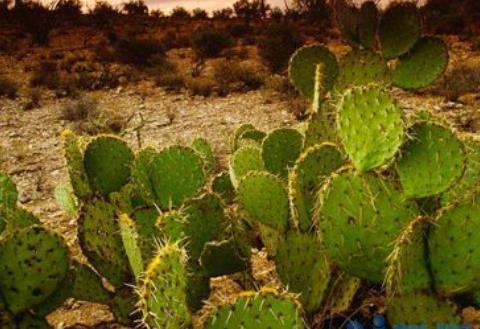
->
258 23 302 72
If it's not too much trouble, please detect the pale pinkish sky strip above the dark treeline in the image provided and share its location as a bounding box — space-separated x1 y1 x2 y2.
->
81 0 284 14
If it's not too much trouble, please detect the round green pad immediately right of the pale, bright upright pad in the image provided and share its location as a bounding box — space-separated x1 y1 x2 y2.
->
396 122 465 198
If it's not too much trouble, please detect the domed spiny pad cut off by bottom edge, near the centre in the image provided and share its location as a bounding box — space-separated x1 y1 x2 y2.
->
204 293 304 329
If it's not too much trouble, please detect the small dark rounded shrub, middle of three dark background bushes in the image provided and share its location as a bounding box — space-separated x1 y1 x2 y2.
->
191 29 233 58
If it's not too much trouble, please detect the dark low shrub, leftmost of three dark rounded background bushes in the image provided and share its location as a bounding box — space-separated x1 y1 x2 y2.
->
114 37 165 66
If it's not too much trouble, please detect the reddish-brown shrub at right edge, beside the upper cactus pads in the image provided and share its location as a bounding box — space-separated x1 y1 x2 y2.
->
435 63 480 101
